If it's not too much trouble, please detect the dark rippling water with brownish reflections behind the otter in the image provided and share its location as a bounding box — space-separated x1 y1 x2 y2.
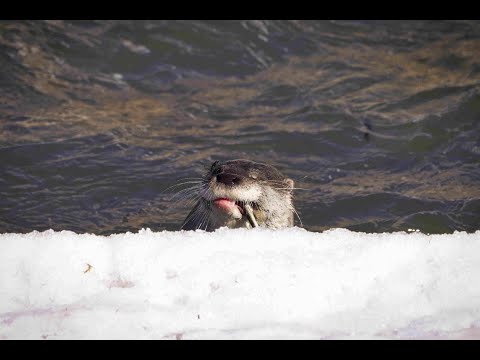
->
0 21 480 234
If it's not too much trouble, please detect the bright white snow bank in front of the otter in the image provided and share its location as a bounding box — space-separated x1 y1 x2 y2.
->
0 228 480 339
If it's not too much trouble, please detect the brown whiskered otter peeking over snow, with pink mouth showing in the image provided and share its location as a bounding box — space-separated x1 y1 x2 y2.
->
181 159 296 231
